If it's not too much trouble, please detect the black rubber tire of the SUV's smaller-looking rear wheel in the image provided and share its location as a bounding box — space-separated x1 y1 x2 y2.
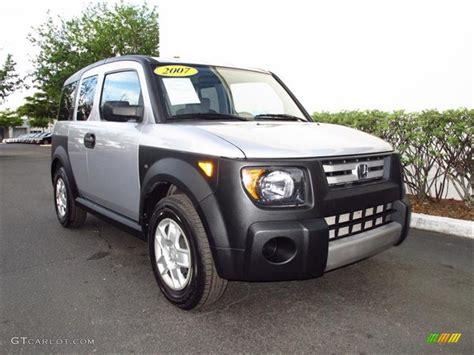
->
53 166 87 228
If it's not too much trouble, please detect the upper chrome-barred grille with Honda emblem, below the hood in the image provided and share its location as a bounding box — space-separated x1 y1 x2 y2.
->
322 155 388 188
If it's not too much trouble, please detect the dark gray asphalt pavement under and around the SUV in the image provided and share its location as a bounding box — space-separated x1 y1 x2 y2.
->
0 144 474 354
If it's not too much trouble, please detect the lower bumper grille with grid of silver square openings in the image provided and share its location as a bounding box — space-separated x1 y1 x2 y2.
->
325 203 395 241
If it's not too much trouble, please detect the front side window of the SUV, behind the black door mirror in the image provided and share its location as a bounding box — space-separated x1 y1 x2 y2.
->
100 71 143 119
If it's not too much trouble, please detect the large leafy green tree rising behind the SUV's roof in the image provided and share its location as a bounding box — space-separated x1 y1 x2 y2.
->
29 2 159 102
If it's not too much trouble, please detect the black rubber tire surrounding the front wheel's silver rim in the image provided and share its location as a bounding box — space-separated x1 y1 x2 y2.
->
148 194 227 310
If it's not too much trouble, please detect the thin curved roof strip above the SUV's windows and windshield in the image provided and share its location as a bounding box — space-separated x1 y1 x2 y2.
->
64 55 268 85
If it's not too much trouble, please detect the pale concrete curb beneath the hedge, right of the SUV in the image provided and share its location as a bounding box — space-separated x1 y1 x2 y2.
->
410 213 474 239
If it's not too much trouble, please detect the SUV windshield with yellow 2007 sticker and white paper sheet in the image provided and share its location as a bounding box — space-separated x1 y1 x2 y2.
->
154 64 307 121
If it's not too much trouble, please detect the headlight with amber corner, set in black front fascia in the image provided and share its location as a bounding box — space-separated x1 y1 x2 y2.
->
242 167 305 206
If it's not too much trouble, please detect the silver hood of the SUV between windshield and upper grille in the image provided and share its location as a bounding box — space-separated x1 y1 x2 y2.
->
194 121 393 158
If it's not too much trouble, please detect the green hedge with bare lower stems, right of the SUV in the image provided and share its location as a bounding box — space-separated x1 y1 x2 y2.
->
313 109 474 207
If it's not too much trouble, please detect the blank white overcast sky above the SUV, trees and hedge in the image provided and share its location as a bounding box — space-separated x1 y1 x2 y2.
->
0 0 474 112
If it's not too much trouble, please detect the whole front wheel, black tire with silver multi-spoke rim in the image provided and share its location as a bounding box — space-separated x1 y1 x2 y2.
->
148 194 227 310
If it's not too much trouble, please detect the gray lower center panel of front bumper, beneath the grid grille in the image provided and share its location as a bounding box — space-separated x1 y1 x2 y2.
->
325 222 402 271
